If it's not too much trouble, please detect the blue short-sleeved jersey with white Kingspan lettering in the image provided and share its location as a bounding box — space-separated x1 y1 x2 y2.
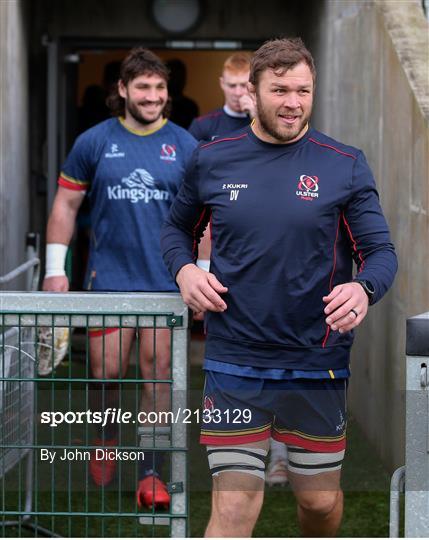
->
58 118 197 292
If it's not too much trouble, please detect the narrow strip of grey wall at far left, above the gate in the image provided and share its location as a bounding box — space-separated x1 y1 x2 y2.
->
0 0 30 288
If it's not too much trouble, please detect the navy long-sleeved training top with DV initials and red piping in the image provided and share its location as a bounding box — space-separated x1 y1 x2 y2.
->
161 127 397 370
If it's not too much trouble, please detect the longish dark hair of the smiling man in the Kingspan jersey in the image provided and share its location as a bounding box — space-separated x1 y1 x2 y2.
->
107 47 168 116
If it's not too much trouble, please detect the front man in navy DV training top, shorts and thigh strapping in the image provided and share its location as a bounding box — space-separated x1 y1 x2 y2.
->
162 38 397 536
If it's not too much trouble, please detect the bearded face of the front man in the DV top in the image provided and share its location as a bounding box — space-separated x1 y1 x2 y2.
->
249 62 314 144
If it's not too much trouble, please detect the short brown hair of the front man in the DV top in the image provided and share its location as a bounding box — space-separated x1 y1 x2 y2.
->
249 38 316 86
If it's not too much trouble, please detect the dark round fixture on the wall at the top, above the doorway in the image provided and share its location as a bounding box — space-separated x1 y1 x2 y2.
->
151 0 201 34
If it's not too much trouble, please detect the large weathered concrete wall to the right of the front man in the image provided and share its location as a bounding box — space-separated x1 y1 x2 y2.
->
316 0 429 468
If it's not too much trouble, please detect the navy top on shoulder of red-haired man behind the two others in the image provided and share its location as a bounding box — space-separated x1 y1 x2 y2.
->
188 108 251 141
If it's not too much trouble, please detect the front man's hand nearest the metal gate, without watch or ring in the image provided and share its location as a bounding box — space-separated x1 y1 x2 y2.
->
176 264 228 313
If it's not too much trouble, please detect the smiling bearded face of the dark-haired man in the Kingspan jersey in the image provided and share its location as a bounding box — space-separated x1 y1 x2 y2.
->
118 73 168 129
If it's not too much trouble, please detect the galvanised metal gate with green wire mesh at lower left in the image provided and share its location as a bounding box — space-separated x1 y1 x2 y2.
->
0 292 188 537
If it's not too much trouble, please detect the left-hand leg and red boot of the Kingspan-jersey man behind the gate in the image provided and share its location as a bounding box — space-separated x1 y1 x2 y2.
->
89 328 135 485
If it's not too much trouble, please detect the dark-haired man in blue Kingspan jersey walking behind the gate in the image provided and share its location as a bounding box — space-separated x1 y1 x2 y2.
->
43 48 196 507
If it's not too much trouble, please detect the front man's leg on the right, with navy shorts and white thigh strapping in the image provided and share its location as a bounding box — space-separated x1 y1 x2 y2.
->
274 379 346 536
